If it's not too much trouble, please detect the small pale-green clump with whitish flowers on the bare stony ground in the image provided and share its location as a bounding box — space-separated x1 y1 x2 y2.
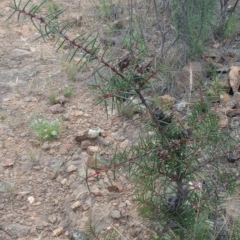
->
31 118 60 140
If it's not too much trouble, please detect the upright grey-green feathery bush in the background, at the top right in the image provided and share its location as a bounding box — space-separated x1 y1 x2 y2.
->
170 0 217 57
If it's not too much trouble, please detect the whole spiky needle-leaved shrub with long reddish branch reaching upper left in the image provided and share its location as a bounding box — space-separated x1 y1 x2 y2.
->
7 0 239 240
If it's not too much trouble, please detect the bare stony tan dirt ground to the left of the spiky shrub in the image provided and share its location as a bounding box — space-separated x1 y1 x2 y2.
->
0 1 142 240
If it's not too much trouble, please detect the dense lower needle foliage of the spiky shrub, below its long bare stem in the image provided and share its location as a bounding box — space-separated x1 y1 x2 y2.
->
117 101 236 239
